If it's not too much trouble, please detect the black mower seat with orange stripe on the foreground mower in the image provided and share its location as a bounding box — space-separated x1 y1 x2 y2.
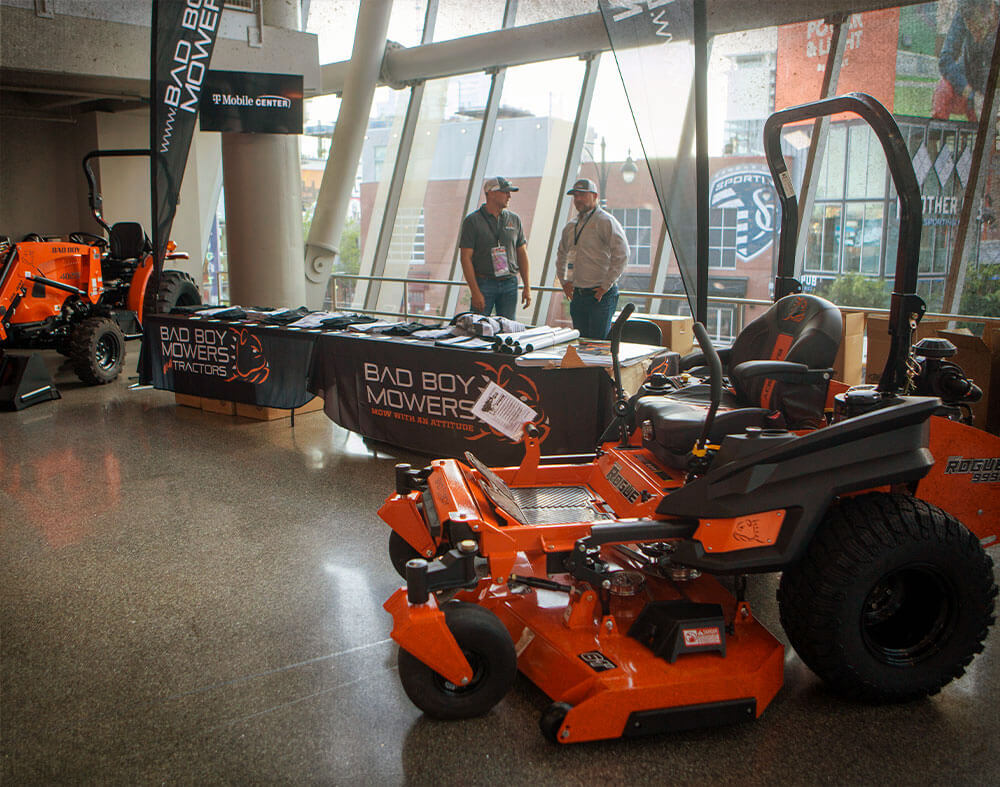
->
635 294 843 468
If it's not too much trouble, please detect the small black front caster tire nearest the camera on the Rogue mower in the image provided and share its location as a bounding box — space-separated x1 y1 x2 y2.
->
398 601 517 721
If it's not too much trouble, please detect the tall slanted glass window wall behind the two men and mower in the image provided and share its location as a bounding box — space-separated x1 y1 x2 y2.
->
304 0 1000 332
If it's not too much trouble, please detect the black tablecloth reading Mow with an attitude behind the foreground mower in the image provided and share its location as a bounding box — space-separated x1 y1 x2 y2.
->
308 334 613 465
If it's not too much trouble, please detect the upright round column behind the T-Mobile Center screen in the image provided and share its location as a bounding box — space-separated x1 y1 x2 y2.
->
222 0 305 307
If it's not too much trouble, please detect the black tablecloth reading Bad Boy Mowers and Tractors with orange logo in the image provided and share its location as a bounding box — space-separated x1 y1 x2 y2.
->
143 315 320 410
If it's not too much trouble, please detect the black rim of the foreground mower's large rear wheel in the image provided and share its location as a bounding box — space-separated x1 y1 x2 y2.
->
861 565 958 666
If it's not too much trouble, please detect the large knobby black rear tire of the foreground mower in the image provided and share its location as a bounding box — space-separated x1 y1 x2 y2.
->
778 493 997 702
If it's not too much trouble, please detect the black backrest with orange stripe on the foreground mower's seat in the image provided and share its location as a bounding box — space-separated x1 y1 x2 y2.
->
729 293 844 429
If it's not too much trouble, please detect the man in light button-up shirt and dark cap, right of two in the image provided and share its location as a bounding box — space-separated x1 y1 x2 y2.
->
556 178 629 339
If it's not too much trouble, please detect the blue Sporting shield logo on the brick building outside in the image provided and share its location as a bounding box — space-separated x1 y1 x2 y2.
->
711 164 777 261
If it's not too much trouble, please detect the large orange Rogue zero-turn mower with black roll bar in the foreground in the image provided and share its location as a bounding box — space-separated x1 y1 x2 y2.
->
379 94 1000 743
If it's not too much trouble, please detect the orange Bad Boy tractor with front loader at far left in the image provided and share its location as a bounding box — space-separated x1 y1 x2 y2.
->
0 150 201 385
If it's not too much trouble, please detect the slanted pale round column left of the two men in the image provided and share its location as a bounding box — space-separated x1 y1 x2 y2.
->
299 0 392 309
